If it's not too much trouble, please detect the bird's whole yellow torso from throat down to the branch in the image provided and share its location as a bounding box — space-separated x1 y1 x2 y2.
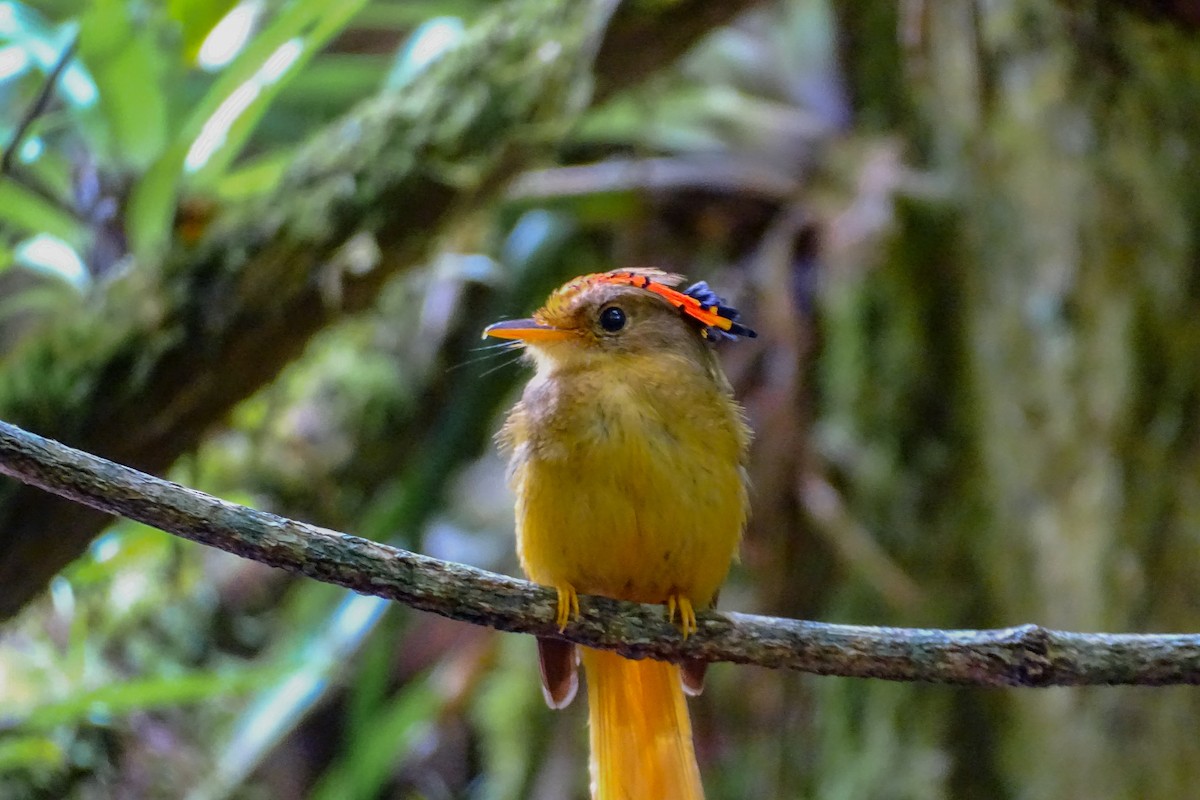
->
502 355 749 607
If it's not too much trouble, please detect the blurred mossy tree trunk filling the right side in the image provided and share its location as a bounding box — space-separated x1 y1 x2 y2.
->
811 1 1200 800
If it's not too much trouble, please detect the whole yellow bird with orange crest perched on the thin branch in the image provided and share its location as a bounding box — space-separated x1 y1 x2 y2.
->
484 269 755 800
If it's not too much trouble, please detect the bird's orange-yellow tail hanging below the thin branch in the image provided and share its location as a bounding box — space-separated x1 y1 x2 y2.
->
582 648 704 800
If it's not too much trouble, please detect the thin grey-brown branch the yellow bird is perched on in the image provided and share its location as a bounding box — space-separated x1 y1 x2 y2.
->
0 422 1200 686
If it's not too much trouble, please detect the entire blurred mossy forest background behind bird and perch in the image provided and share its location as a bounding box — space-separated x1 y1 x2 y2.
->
0 0 1200 800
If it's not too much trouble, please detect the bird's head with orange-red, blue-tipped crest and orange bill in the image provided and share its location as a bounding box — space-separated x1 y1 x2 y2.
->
484 269 755 371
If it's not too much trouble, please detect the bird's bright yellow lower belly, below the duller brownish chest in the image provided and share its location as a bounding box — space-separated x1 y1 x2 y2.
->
514 407 745 607
